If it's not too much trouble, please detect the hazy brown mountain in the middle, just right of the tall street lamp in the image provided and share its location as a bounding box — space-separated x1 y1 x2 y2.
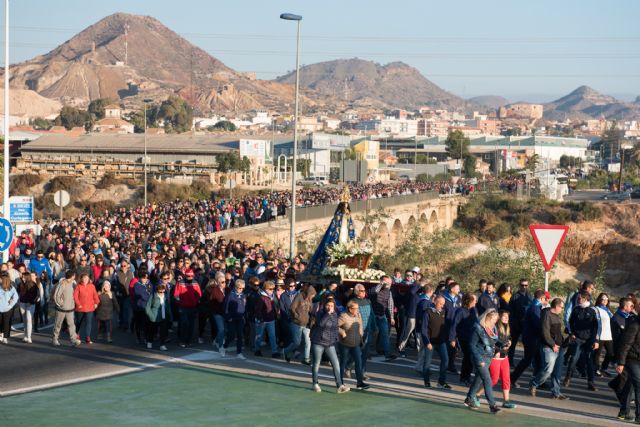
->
276 58 466 109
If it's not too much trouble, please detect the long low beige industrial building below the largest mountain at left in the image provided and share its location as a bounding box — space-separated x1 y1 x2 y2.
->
14 134 286 185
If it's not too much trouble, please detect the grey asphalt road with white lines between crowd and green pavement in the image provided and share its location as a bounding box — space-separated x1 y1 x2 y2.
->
0 322 621 425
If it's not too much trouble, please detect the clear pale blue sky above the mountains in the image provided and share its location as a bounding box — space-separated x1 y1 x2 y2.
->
5 0 640 101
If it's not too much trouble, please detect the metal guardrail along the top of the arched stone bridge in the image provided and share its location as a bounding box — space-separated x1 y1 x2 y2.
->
285 191 439 222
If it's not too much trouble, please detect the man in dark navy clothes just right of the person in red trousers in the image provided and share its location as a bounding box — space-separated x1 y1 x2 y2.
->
511 289 548 387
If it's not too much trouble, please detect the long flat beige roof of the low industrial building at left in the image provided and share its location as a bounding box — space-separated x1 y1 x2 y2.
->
22 133 290 154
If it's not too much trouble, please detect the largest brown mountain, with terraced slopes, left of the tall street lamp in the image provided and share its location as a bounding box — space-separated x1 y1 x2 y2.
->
2 13 308 112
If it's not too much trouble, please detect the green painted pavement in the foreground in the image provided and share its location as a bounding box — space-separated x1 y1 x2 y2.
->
0 365 576 427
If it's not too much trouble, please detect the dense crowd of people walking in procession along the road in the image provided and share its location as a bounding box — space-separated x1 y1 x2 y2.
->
0 184 640 422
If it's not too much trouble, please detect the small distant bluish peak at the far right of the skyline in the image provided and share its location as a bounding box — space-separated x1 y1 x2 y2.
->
544 86 640 120
